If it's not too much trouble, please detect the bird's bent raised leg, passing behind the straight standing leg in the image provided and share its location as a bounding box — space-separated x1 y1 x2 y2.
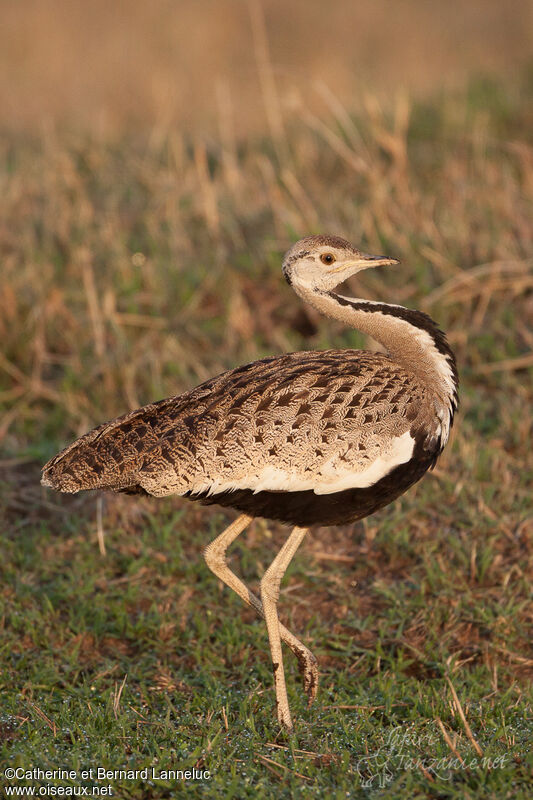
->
204 514 318 705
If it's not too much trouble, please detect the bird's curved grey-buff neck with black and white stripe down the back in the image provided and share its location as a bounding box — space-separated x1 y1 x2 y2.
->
294 286 458 432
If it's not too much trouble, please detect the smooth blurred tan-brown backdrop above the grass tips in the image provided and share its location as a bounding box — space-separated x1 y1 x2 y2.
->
0 0 533 134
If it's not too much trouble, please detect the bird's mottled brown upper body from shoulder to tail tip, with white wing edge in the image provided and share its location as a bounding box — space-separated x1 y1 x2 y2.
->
43 350 438 516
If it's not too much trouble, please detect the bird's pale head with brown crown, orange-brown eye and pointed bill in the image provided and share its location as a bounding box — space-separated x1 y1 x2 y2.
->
283 236 400 292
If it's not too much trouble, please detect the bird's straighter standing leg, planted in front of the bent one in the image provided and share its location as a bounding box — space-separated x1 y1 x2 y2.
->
261 527 307 732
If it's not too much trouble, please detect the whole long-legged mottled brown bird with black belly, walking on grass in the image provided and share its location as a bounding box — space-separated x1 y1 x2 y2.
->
41 235 459 732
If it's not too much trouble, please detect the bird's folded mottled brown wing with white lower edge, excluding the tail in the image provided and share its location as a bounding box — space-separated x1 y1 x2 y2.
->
138 350 434 496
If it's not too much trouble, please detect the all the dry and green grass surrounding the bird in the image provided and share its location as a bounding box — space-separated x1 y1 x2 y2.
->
0 72 533 798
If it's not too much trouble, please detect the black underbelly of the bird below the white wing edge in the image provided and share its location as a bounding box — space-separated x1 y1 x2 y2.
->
189 448 436 528
